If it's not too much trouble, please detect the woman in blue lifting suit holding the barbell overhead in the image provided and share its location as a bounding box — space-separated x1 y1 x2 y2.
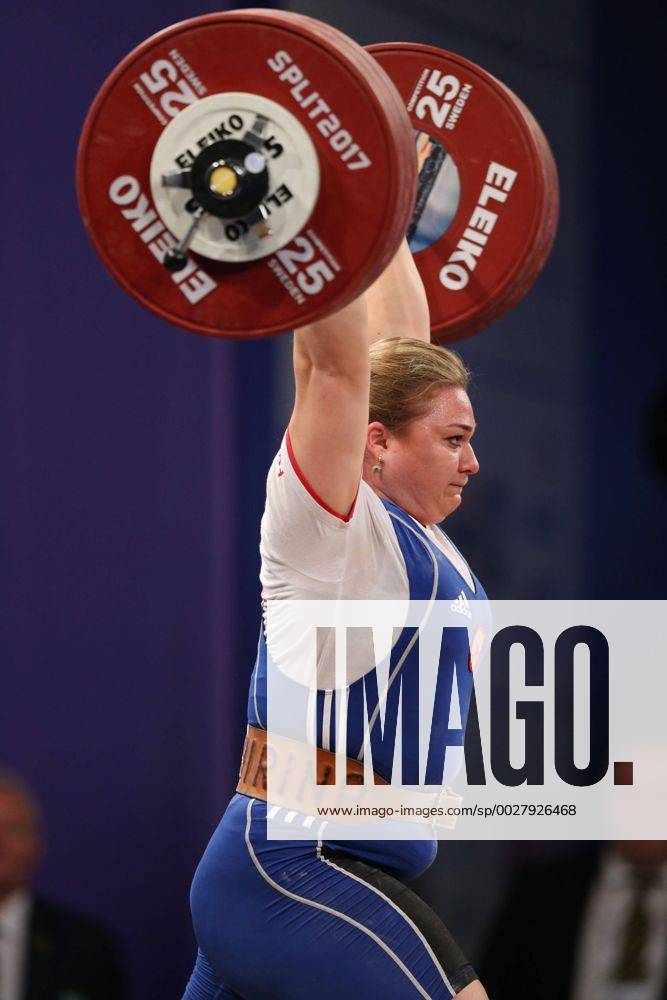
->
185 243 487 1000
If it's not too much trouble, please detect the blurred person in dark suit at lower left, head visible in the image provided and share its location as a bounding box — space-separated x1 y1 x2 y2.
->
0 771 127 1000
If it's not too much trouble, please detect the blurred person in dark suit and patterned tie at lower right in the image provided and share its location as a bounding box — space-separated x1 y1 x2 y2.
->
479 841 667 1000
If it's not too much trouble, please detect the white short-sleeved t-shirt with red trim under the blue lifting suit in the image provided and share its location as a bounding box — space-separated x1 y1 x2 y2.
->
260 431 475 688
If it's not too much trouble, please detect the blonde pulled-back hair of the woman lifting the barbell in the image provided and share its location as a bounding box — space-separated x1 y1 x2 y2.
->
368 337 470 433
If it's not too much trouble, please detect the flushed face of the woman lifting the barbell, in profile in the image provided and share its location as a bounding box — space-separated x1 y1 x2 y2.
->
368 386 479 524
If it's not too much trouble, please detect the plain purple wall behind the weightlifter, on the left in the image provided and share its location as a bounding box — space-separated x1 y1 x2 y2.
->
0 0 275 1000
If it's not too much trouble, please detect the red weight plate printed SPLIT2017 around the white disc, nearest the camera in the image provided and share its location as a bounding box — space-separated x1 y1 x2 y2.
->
77 10 416 337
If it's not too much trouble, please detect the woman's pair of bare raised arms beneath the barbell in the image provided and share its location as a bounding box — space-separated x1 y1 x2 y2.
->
289 240 430 517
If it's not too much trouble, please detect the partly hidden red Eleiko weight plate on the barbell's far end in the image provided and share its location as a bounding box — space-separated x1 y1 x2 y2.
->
368 43 558 343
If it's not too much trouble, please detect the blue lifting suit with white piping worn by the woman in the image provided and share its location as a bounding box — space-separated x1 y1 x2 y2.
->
184 488 486 1000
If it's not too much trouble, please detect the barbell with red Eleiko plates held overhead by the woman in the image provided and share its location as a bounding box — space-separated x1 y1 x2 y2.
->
77 10 558 343
